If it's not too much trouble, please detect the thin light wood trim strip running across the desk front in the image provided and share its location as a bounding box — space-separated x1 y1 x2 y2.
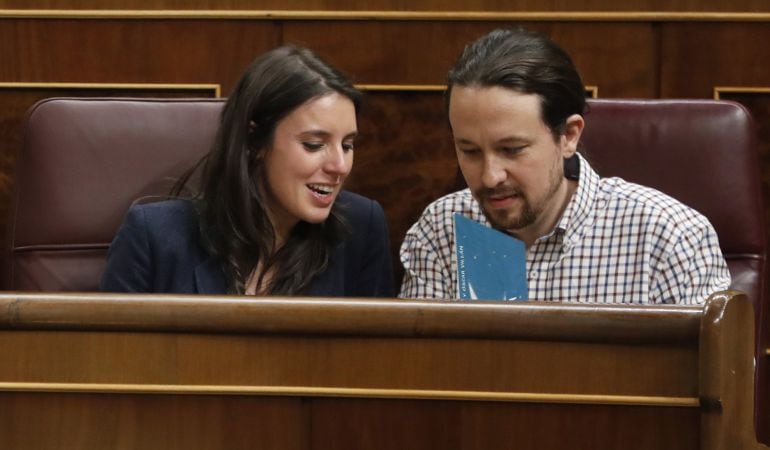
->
0 382 700 408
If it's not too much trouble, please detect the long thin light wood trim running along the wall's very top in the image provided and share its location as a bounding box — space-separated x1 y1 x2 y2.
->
0 9 770 22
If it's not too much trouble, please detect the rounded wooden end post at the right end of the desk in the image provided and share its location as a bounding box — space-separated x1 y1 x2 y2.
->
699 291 767 450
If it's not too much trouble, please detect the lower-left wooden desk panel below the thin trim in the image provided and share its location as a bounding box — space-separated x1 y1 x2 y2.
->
0 392 309 450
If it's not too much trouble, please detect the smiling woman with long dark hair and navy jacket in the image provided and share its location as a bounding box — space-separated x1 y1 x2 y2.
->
101 46 394 297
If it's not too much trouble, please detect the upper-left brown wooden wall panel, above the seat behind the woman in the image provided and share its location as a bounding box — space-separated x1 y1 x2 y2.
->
0 19 280 90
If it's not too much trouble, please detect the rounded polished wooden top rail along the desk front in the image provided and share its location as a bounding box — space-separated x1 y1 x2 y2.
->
0 293 702 345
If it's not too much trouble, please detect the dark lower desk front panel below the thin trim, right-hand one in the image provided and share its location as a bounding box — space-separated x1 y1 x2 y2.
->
312 399 700 450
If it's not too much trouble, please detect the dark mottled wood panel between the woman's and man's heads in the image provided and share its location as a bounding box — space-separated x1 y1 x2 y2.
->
347 91 458 279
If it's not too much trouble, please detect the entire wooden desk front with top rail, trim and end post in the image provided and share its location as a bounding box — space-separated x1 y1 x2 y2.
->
0 292 762 450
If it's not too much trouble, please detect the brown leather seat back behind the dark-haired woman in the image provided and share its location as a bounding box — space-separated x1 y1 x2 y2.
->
3 98 224 291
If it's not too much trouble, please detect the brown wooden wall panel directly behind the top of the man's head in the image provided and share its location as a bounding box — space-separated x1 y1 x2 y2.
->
283 21 658 97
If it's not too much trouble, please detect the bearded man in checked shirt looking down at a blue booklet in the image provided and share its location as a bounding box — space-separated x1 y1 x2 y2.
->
400 29 730 304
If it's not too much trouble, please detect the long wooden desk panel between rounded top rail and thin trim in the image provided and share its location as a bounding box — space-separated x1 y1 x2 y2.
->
0 330 698 397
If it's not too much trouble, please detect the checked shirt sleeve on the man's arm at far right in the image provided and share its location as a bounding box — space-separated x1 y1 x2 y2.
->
650 219 730 305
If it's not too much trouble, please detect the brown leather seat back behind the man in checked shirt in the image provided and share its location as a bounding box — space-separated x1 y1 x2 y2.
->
582 100 766 311
